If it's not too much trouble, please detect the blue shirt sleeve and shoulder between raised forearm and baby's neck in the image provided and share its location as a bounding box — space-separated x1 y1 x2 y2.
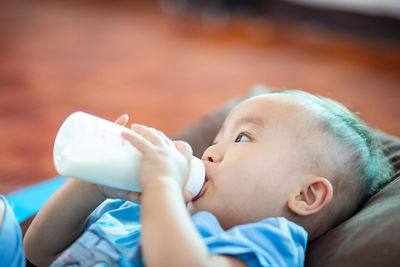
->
192 212 307 266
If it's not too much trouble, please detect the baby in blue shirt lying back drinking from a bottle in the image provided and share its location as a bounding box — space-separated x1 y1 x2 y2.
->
24 91 392 266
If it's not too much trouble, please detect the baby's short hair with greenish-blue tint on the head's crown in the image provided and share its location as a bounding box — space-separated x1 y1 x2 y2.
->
271 90 393 213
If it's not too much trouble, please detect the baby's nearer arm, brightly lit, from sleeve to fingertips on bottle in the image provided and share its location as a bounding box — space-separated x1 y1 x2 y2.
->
123 125 246 267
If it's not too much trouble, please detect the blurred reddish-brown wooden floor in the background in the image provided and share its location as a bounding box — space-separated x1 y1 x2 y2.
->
0 1 400 194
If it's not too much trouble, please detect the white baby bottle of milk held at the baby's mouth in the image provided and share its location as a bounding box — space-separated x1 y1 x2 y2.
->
53 112 205 198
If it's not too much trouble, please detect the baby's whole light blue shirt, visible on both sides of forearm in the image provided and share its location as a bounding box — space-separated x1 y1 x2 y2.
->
52 200 307 266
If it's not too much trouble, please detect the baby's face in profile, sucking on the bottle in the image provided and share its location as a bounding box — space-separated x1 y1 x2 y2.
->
189 94 318 229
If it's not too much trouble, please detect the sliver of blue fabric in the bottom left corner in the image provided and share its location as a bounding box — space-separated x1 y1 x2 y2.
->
0 195 25 267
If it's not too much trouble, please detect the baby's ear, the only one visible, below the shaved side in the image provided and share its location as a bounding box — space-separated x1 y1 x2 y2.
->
288 177 333 216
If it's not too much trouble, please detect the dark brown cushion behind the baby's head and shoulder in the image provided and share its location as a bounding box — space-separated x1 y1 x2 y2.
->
175 86 400 267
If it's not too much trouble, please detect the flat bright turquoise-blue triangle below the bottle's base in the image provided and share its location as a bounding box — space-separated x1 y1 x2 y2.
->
6 177 68 223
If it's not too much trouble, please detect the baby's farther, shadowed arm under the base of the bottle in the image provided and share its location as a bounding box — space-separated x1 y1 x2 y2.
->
24 179 105 266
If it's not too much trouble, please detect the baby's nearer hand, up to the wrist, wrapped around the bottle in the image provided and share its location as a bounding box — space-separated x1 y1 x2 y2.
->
122 125 192 199
